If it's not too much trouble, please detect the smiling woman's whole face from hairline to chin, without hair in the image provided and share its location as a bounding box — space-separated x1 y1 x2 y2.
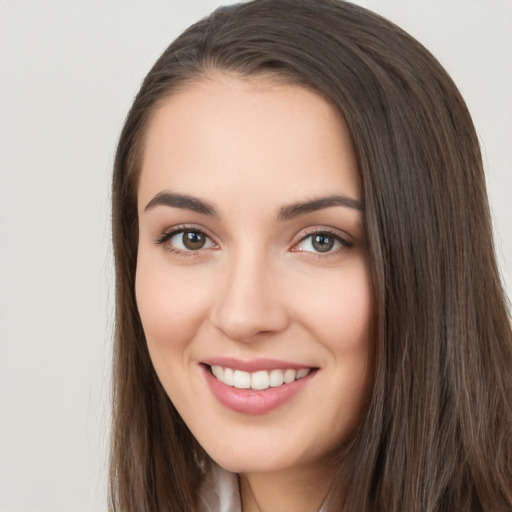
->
136 74 373 473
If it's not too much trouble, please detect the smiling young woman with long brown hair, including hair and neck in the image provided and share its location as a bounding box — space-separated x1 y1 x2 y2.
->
111 0 512 512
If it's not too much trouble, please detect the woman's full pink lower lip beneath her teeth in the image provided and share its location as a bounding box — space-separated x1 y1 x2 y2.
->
203 366 316 414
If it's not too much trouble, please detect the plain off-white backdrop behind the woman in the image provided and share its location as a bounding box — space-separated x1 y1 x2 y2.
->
0 0 512 512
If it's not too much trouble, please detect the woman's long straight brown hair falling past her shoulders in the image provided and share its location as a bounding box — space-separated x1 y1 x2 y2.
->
110 0 512 512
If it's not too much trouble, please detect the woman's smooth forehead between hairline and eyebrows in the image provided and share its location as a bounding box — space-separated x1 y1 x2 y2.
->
138 74 360 213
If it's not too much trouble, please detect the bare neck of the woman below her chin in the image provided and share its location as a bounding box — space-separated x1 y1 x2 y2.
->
240 460 332 512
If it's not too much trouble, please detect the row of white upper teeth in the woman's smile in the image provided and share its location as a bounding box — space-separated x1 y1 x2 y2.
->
211 365 311 391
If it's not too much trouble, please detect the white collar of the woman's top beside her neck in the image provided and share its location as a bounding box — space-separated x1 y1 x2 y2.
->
199 463 327 512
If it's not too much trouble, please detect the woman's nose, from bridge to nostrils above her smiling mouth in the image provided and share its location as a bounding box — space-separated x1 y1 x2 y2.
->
211 249 289 343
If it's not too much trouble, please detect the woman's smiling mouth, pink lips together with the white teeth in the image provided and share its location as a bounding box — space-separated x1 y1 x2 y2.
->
201 358 317 414
